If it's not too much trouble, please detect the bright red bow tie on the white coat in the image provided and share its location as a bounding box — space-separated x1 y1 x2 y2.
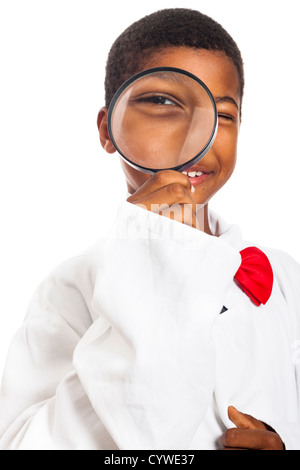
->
234 246 273 305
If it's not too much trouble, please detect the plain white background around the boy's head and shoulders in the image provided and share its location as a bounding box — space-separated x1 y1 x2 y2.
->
0 0 300 372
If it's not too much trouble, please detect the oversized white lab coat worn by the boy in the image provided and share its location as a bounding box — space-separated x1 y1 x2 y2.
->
0 201 300 450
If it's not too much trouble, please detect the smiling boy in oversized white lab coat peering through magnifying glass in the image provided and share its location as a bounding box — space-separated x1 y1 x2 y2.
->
0 9 300 450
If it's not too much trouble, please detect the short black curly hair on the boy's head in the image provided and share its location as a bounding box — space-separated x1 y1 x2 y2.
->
105 8 244 107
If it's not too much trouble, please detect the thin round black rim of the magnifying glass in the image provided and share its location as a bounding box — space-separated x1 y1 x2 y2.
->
107 67 218 174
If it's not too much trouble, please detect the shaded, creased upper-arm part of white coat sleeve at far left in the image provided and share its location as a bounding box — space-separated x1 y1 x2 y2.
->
0 260 115 450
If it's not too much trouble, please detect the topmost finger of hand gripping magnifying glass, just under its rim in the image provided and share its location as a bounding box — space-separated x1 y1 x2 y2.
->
127 170 194 202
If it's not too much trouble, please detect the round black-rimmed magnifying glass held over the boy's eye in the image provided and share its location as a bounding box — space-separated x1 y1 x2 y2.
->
108 67 218 174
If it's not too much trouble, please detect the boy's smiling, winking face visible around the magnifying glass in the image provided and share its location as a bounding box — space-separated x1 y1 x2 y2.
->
98 47 241 204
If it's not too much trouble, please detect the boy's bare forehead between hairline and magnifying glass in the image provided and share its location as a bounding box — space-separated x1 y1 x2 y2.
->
143 47 240 109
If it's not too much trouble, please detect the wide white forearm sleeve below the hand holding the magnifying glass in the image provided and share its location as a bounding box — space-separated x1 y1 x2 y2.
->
74 202 240 449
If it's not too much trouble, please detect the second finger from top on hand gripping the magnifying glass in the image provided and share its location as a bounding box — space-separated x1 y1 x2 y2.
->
129 183 197 215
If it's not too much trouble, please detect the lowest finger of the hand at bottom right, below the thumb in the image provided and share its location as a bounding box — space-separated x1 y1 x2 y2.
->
221 428 284 450
